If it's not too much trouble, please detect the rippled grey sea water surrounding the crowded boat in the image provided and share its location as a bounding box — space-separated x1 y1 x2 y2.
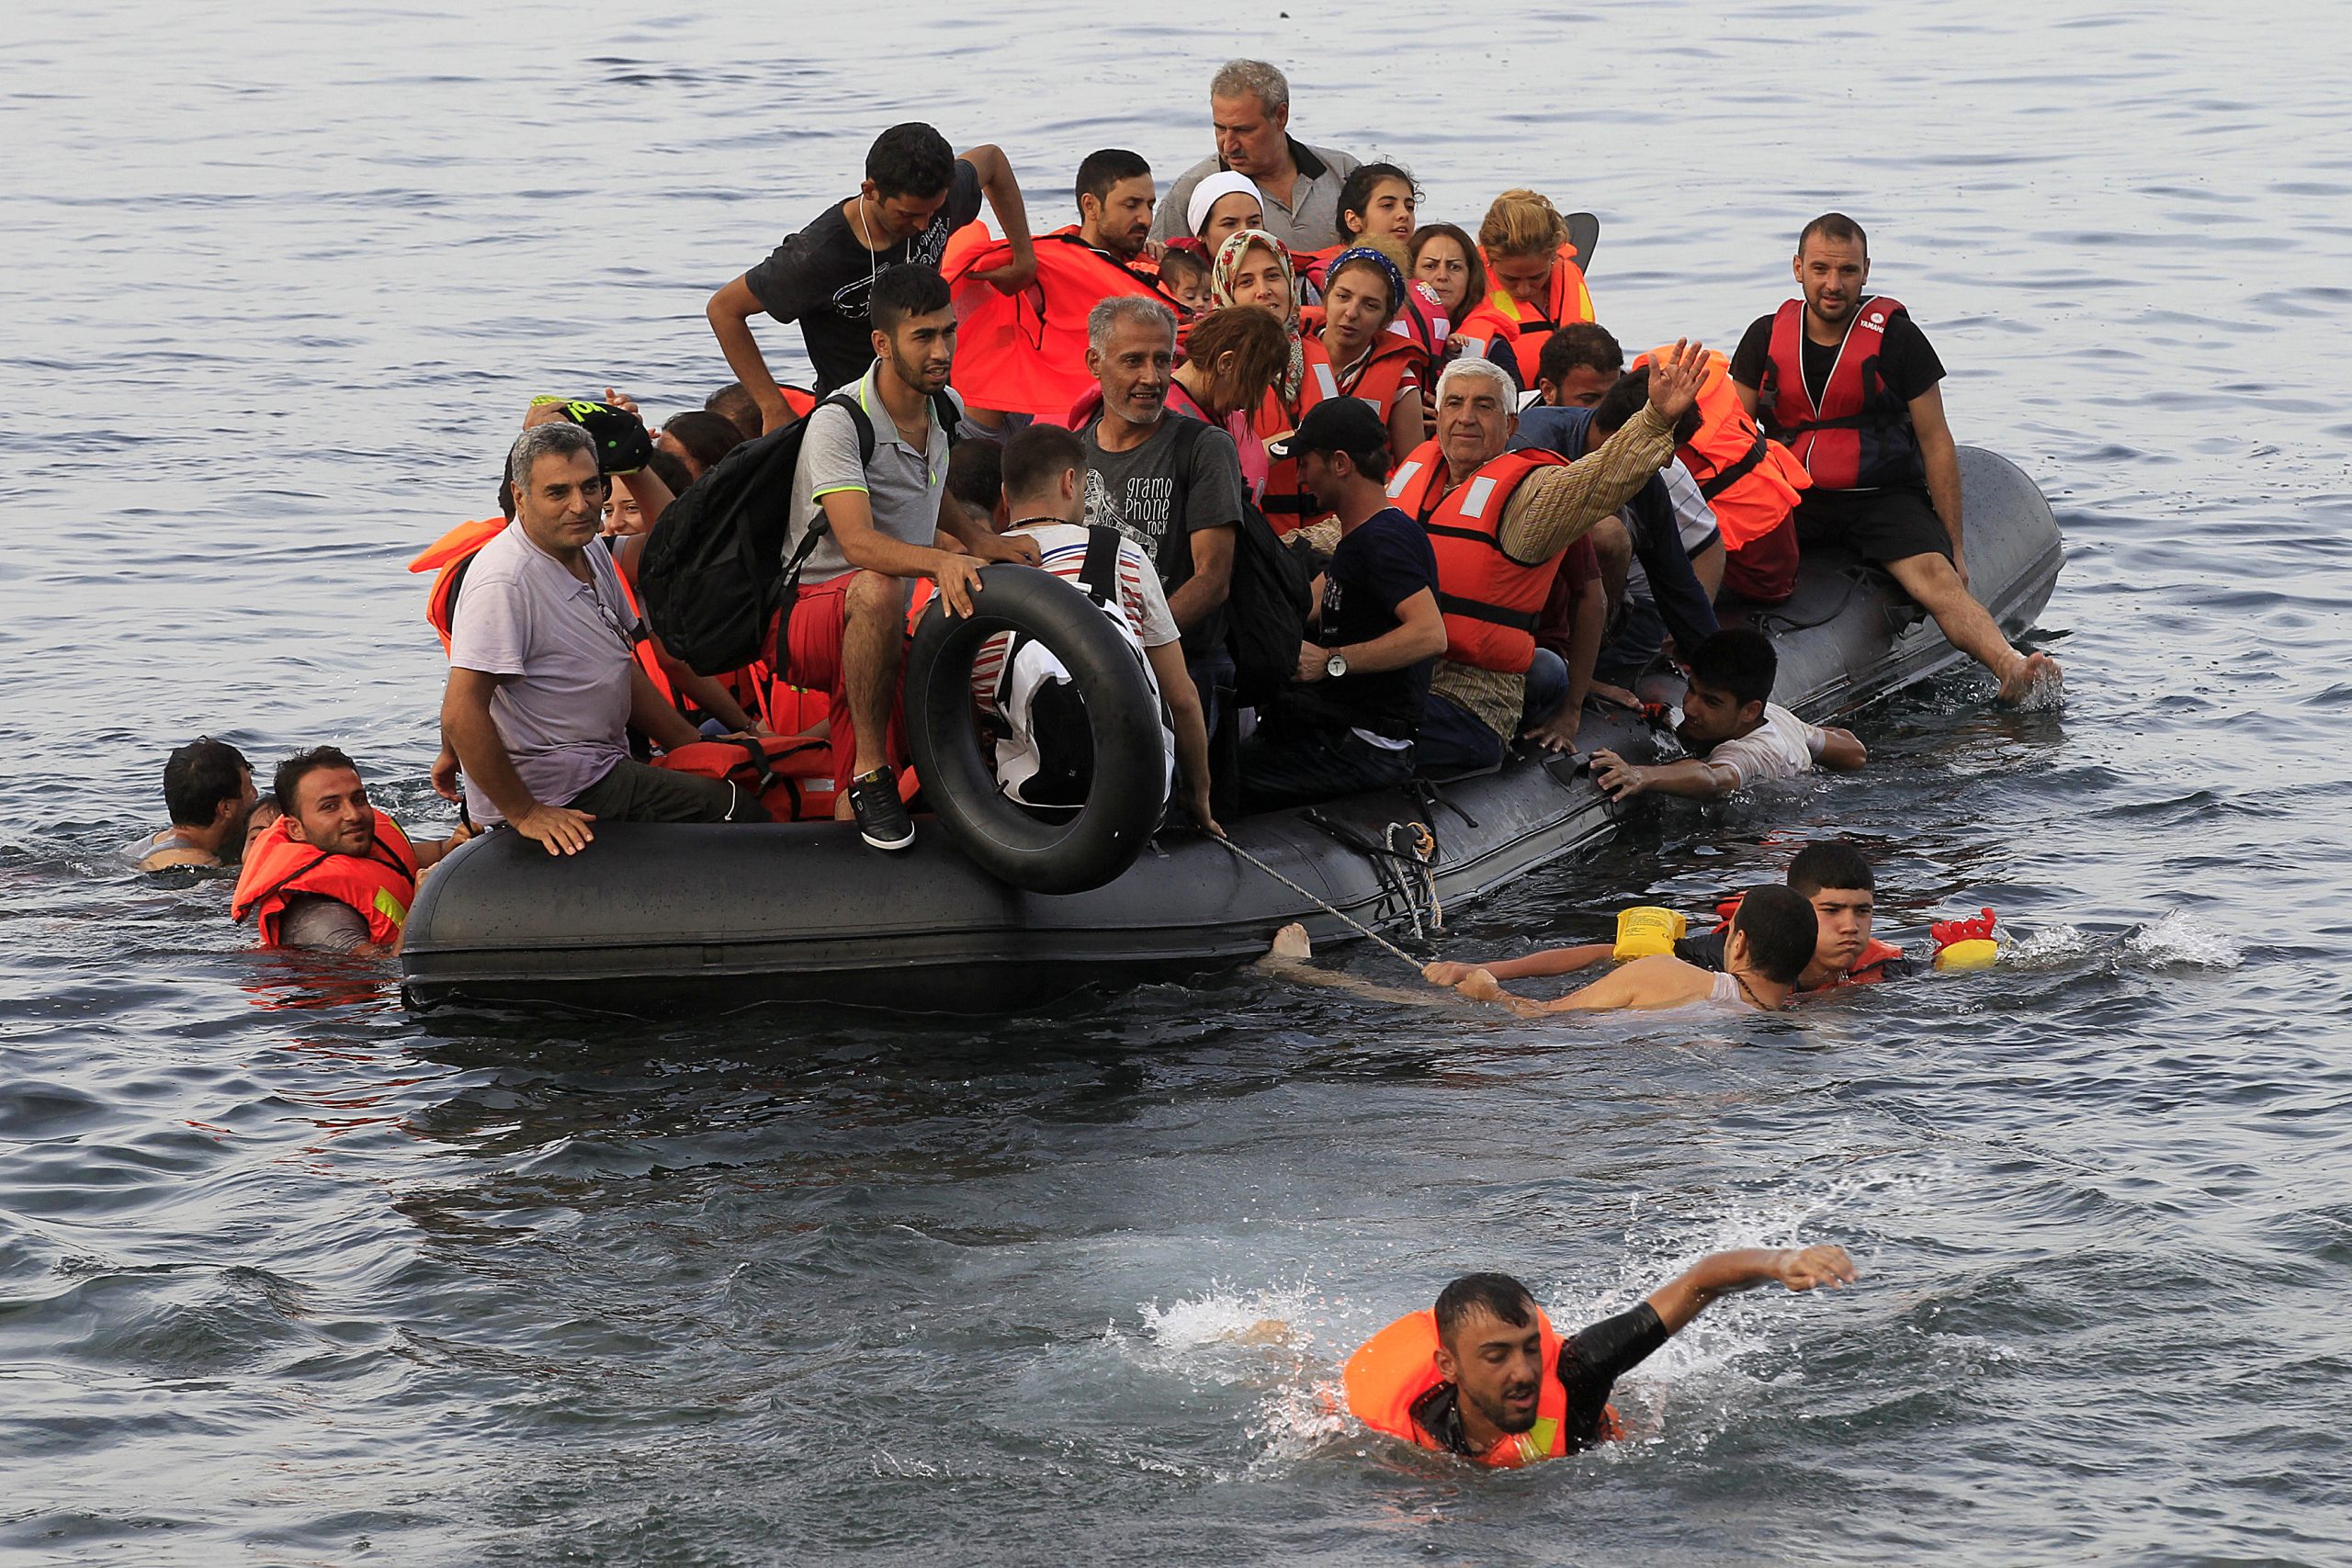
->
0 0 2352 1563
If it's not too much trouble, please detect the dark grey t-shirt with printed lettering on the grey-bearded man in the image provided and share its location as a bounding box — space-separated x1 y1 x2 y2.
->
1084 413 1242 659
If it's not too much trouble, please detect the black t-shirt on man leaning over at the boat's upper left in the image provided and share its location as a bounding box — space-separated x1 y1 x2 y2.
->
743 157 981 395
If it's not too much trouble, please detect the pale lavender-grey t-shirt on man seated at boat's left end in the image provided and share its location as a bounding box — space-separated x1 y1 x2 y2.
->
449 522 642 825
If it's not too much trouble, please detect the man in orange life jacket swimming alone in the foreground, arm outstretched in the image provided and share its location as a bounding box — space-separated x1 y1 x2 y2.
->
1340 1246 1853 1470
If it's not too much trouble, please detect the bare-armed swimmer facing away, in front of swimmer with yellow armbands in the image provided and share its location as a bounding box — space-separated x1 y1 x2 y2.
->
1259 886 1818 1018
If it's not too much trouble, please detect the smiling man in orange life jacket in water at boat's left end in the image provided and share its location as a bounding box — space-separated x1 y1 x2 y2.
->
228 745 473 957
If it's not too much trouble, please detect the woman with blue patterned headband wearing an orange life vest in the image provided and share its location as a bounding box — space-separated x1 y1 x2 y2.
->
1259 247 1425 534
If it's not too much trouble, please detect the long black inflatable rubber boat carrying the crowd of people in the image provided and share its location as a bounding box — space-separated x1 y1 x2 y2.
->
402 446 2063 1018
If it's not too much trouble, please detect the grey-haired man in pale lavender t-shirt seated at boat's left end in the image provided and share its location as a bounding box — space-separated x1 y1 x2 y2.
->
442 421 767 856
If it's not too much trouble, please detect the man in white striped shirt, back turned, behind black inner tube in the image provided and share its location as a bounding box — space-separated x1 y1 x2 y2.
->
971 415 1223 837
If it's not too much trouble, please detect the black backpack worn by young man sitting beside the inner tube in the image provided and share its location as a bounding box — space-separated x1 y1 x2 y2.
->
638 392 957 674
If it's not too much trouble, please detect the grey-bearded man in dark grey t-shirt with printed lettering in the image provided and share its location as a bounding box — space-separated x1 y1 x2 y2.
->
1080 294 1244 739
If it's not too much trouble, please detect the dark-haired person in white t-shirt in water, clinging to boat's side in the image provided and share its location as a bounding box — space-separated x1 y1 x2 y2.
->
1592 627 1868 802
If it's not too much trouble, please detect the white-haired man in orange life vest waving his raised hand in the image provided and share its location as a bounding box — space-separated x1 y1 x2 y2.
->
1387 341 1705 773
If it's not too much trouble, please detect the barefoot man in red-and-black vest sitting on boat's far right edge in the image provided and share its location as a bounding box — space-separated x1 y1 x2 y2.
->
1731 211 2058 703
